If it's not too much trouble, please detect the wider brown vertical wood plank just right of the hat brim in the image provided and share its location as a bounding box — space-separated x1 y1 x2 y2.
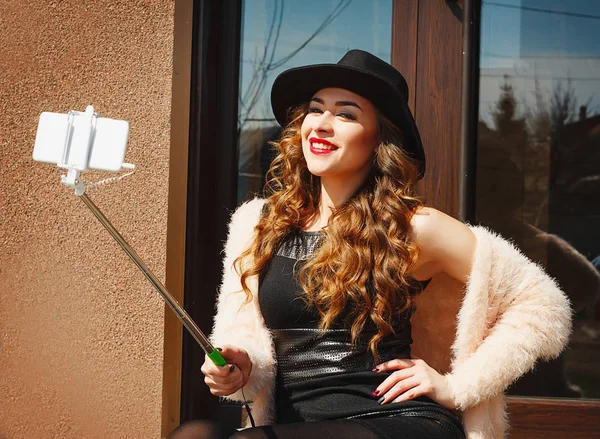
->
415 1 462 217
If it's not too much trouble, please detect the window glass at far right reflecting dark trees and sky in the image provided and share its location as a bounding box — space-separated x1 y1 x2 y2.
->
476 0 600 398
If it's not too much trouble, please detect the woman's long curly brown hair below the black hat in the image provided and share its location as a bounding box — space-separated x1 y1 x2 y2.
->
234 105 423 359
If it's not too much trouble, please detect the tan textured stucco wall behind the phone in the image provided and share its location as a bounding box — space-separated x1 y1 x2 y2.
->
0 0 174 439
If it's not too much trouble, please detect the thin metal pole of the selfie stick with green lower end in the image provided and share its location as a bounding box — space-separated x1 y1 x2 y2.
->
77 192 227 366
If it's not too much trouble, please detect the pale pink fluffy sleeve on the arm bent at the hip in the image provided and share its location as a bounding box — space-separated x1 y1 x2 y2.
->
446 227 571 437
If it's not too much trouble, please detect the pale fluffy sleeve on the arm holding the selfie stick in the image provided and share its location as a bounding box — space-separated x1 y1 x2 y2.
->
206 199 275 401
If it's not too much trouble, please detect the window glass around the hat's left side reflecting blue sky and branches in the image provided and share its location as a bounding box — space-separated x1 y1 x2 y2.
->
238 0 392 202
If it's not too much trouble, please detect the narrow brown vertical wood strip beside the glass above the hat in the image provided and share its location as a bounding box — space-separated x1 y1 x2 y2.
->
391 0 419 114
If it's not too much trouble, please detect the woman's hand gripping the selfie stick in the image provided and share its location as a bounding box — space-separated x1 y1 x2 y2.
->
200 346 252 396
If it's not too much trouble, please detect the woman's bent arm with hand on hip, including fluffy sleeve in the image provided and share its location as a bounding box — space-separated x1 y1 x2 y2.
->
377 209 571 409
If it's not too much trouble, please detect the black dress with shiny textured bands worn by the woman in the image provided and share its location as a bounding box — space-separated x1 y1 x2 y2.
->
259 232 462 437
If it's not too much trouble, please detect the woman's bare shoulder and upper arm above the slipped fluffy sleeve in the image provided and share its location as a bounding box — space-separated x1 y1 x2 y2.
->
408 207 476 280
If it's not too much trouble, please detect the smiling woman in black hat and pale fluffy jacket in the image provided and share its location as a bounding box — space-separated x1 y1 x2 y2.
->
171 50 570 438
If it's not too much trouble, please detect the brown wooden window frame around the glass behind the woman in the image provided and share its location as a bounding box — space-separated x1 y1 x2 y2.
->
162 0 600 439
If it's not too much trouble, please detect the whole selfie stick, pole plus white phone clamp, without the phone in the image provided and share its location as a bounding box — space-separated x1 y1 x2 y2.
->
58 106 227 366
